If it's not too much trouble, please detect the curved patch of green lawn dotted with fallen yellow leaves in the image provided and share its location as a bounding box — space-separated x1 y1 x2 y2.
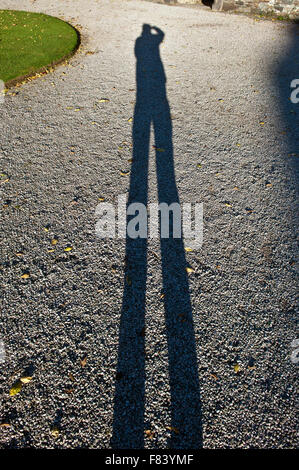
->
0 10 79 82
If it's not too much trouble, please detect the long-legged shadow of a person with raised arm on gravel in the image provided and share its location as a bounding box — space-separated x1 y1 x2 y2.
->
111 24 202 449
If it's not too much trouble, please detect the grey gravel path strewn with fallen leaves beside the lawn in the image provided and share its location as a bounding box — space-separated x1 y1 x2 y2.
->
0 0 299 449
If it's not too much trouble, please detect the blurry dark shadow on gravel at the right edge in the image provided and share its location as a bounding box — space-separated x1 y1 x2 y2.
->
273 23 299 182
